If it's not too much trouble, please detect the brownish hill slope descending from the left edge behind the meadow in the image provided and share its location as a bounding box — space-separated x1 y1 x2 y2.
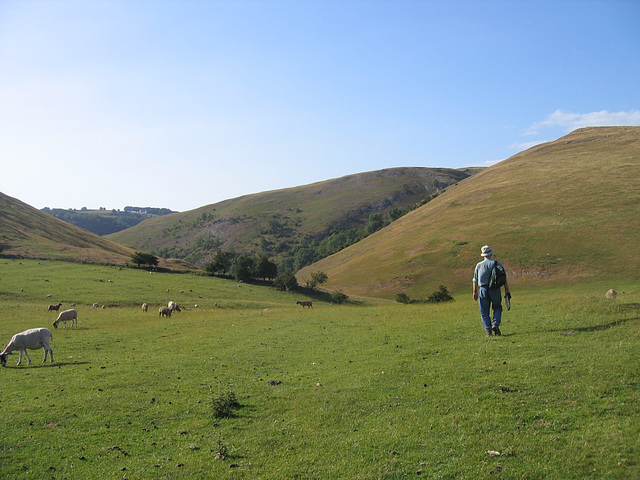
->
0 193 193 270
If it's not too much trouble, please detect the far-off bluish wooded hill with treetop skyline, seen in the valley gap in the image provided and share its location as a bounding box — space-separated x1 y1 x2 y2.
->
42 207 176 235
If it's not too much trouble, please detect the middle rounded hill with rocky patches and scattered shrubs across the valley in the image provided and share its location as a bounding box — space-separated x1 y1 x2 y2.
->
107 167 478 266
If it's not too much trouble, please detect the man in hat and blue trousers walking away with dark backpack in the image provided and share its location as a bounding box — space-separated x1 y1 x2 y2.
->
473 245 511 337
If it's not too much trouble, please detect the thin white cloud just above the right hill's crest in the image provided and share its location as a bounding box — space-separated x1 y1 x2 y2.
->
525 110 640 135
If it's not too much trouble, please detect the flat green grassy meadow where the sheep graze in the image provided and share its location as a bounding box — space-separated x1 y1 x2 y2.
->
0 259 640 479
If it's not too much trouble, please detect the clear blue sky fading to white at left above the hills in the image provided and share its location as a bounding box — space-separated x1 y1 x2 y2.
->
0 0 640 211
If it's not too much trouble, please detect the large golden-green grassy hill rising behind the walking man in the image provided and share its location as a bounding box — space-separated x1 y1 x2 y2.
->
298 127 640 298
